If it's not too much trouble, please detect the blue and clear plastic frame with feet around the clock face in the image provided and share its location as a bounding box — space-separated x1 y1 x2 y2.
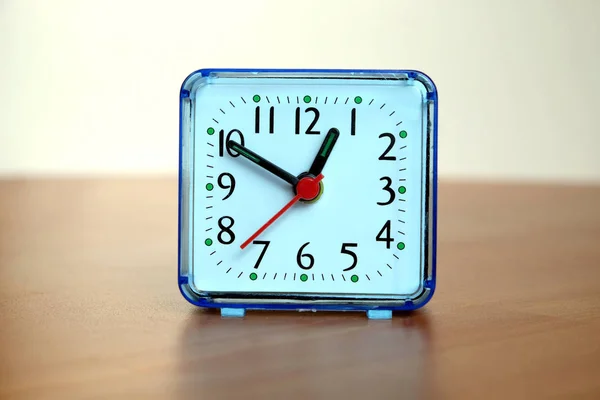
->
177 68 438 319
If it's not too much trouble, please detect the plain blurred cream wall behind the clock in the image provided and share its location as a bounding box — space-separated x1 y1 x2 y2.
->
0 0 600 181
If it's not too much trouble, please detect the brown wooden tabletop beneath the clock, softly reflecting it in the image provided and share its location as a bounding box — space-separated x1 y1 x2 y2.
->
0 179 600 400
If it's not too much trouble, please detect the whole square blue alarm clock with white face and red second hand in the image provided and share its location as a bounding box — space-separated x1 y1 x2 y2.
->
178 69 438 319
